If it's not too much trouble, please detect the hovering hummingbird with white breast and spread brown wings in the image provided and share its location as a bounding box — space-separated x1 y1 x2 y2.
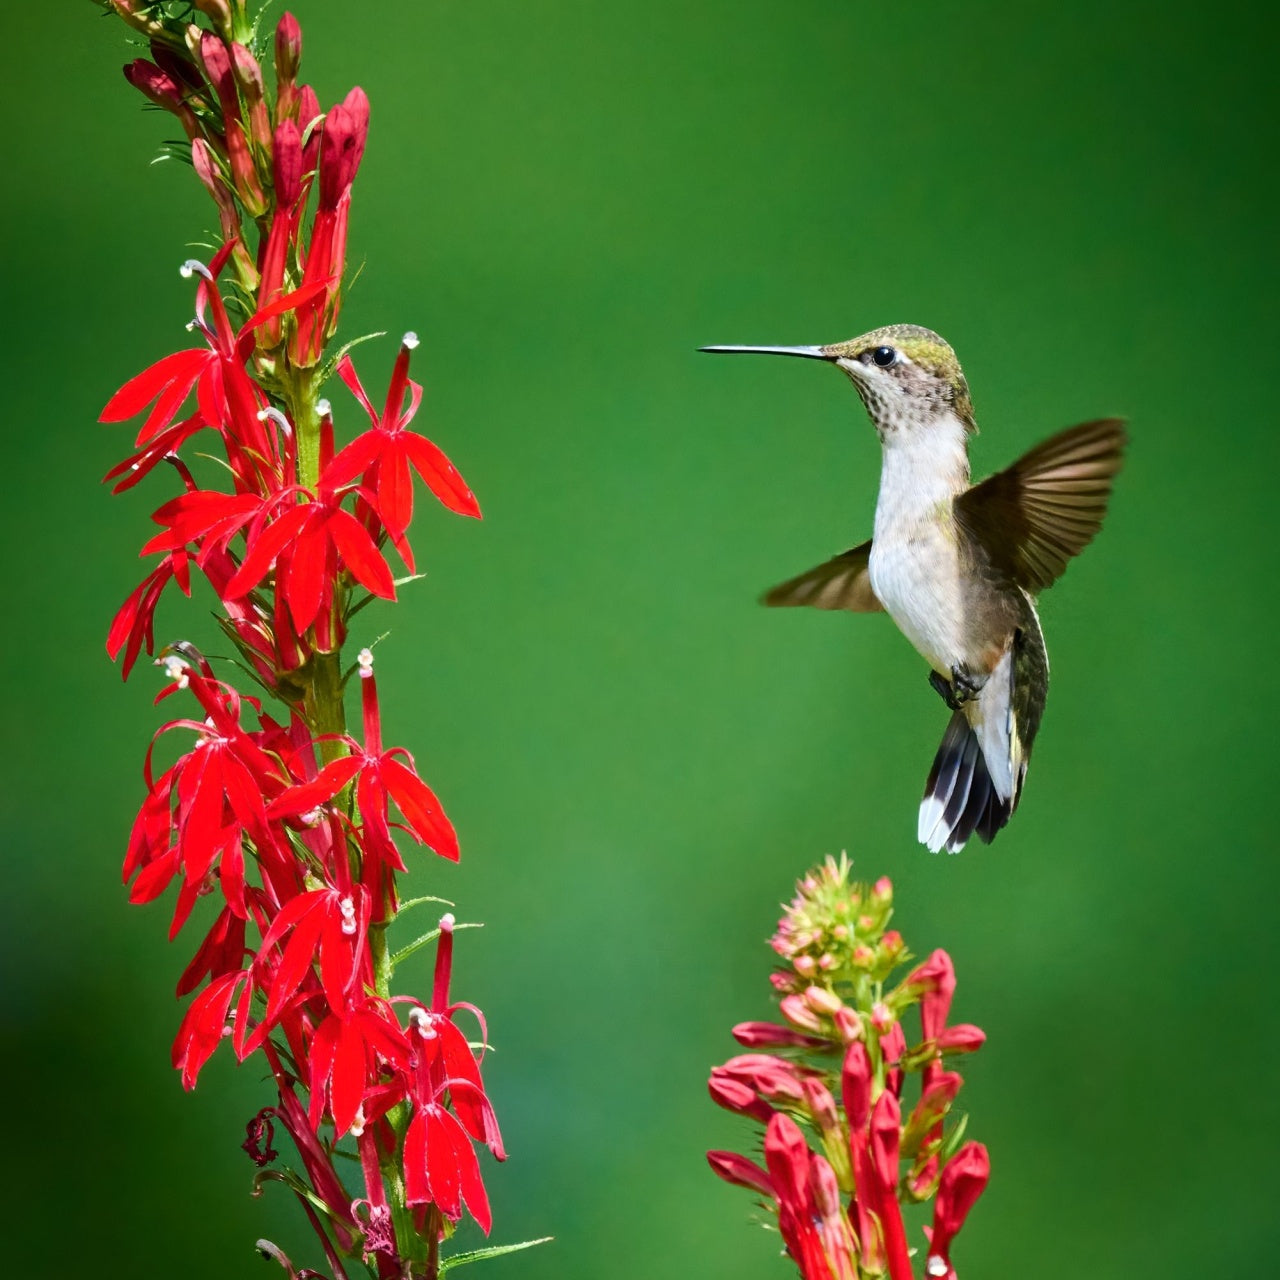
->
701 324 1125 854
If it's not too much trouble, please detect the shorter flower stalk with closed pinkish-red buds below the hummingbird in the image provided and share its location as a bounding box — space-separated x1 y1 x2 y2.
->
707 855 989 1280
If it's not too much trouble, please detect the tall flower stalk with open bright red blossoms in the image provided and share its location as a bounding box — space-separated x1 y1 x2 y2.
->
94 0 532 1280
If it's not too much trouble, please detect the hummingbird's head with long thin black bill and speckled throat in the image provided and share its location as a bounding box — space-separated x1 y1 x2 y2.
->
703 324 978 439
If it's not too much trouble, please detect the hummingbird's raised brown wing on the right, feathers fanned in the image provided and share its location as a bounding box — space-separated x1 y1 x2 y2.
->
955 417 1128 593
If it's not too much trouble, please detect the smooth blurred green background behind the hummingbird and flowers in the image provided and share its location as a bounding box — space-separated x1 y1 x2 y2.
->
0 0 1280 1280
